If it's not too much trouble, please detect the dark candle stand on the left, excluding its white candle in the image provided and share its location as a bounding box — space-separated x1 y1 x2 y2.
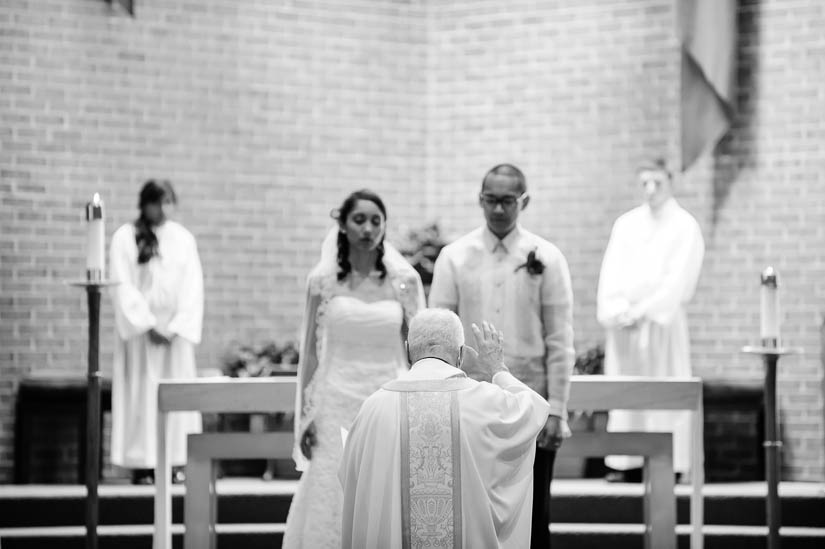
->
67 279 118 549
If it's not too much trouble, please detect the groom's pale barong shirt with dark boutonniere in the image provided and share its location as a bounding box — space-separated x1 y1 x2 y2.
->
429 225 575 418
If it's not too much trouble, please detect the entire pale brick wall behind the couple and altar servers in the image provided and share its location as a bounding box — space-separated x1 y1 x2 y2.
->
0 0 825 480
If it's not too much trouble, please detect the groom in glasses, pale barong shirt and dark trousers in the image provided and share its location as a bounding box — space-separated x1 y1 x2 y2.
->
429 164 575 549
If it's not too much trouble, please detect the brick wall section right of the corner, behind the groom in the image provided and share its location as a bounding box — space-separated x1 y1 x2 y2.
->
427 0 825 480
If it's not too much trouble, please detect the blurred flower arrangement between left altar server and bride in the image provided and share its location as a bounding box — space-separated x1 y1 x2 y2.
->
222 341 298 377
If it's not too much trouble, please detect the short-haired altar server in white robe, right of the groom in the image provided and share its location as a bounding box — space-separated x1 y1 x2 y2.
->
597 160 705 473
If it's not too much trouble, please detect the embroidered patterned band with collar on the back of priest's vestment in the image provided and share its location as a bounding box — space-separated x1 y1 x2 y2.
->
384 378 472 549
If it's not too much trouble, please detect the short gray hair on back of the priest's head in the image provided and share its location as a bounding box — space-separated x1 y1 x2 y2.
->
407 309 464 366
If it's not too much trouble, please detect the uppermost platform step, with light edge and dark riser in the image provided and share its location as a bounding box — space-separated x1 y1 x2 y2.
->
0 478 825 528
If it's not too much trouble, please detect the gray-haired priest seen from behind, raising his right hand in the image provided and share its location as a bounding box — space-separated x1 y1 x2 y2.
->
339 309 550 549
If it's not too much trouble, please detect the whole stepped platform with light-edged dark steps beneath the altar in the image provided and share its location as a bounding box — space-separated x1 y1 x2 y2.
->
0 478 825 549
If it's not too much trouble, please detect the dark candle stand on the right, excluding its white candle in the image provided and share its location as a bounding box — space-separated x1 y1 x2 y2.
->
742 338 802 549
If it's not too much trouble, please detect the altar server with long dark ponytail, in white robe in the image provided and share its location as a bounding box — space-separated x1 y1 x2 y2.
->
110 180 203 484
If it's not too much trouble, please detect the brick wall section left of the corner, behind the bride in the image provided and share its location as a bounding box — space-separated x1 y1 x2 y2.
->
0 0 426 481
